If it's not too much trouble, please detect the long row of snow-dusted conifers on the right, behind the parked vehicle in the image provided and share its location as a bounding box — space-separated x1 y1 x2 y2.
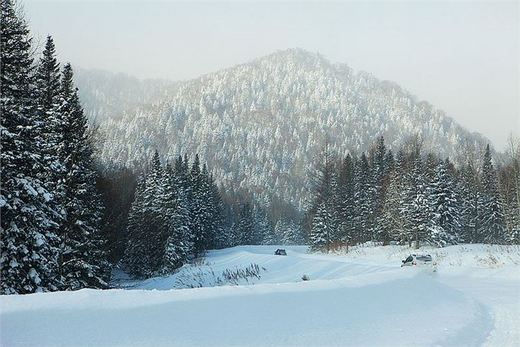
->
304 137 520 251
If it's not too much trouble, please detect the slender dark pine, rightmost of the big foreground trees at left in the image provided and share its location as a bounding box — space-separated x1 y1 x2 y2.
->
59 64 110 289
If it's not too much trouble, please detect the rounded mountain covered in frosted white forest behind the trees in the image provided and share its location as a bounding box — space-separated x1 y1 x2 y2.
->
83 49 488 208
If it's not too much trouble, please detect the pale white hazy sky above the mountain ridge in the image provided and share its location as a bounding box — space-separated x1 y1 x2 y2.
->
23 0 520 150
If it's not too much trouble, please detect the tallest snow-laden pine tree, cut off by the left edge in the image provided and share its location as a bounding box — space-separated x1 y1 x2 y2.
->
0 0 61 294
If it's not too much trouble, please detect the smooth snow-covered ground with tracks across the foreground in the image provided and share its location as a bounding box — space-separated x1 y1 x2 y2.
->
0 245 520 346
